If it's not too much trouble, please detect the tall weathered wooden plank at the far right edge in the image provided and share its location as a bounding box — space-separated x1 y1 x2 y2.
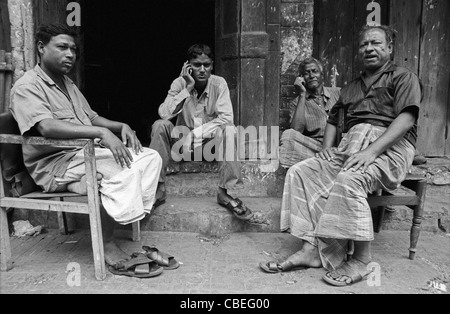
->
418 0 450 156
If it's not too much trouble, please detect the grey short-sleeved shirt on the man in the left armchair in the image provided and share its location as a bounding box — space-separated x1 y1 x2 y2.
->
10 65 98 192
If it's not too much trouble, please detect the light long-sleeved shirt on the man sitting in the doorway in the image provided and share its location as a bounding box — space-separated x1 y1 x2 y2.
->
159 75 233 138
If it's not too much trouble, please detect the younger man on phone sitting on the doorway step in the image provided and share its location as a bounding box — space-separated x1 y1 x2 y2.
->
150 44 266 224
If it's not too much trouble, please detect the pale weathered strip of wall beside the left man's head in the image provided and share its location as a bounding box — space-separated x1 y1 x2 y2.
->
8 0 36 81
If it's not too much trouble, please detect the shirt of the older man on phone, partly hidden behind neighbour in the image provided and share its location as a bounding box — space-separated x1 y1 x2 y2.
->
289 86 341 142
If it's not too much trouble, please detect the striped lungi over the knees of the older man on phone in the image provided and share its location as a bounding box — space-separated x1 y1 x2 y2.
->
280 129 322 168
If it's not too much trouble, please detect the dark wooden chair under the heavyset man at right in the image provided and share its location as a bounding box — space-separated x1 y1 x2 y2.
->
336 108 427 260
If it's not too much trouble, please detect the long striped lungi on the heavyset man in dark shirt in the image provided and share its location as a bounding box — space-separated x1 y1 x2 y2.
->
281 124 415 270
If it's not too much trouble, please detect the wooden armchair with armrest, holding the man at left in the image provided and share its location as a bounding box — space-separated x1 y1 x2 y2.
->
0 51 140 280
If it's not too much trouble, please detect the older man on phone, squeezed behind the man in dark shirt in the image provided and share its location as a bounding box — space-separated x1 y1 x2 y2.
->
280 58 340 168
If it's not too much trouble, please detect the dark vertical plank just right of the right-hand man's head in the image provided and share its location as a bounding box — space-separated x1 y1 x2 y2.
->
390 0 423 74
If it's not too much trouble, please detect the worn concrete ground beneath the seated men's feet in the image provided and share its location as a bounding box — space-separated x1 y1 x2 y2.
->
0 230 450 298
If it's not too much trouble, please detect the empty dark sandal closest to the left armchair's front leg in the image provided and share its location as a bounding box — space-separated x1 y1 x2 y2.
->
108 253 164 278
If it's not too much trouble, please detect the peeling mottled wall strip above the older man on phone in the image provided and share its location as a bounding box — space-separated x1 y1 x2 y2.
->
280 0 314 130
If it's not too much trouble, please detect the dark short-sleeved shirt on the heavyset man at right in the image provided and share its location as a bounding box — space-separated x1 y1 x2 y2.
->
328 62 423 145
